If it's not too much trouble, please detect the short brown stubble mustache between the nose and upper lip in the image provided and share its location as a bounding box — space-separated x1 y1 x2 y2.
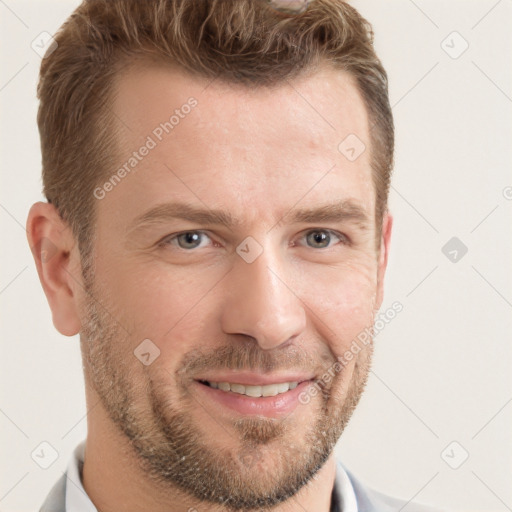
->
177 342 336 377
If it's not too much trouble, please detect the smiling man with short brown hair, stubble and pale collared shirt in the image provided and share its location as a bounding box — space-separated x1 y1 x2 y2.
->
27 0 442 512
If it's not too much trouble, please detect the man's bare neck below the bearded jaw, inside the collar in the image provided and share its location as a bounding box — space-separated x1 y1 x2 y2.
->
83 403 336 512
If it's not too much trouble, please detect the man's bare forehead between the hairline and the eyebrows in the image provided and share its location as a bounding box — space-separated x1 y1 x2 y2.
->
101 59 374 228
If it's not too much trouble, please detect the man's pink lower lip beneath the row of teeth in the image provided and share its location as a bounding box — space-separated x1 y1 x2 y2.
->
194 380 312 418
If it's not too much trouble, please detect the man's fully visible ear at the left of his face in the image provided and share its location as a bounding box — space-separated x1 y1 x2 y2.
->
27 202 83 336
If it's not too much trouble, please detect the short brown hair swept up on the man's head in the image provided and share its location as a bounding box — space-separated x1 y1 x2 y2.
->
37 0 394 256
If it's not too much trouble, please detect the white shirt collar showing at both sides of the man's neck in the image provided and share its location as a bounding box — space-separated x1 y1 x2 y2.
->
66 439 357 512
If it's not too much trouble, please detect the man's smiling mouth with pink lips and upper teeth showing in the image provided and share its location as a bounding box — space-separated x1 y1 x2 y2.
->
194 374 314 417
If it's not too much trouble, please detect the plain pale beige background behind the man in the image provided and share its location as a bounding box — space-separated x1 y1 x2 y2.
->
0 0 512 512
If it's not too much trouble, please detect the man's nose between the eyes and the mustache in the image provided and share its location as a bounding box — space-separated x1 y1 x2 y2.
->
222 242 306 350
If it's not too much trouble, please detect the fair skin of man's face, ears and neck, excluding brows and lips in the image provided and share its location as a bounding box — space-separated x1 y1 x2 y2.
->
27 64 392 512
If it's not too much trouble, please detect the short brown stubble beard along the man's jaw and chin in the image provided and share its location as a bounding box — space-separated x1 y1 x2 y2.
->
80 272 373 511
